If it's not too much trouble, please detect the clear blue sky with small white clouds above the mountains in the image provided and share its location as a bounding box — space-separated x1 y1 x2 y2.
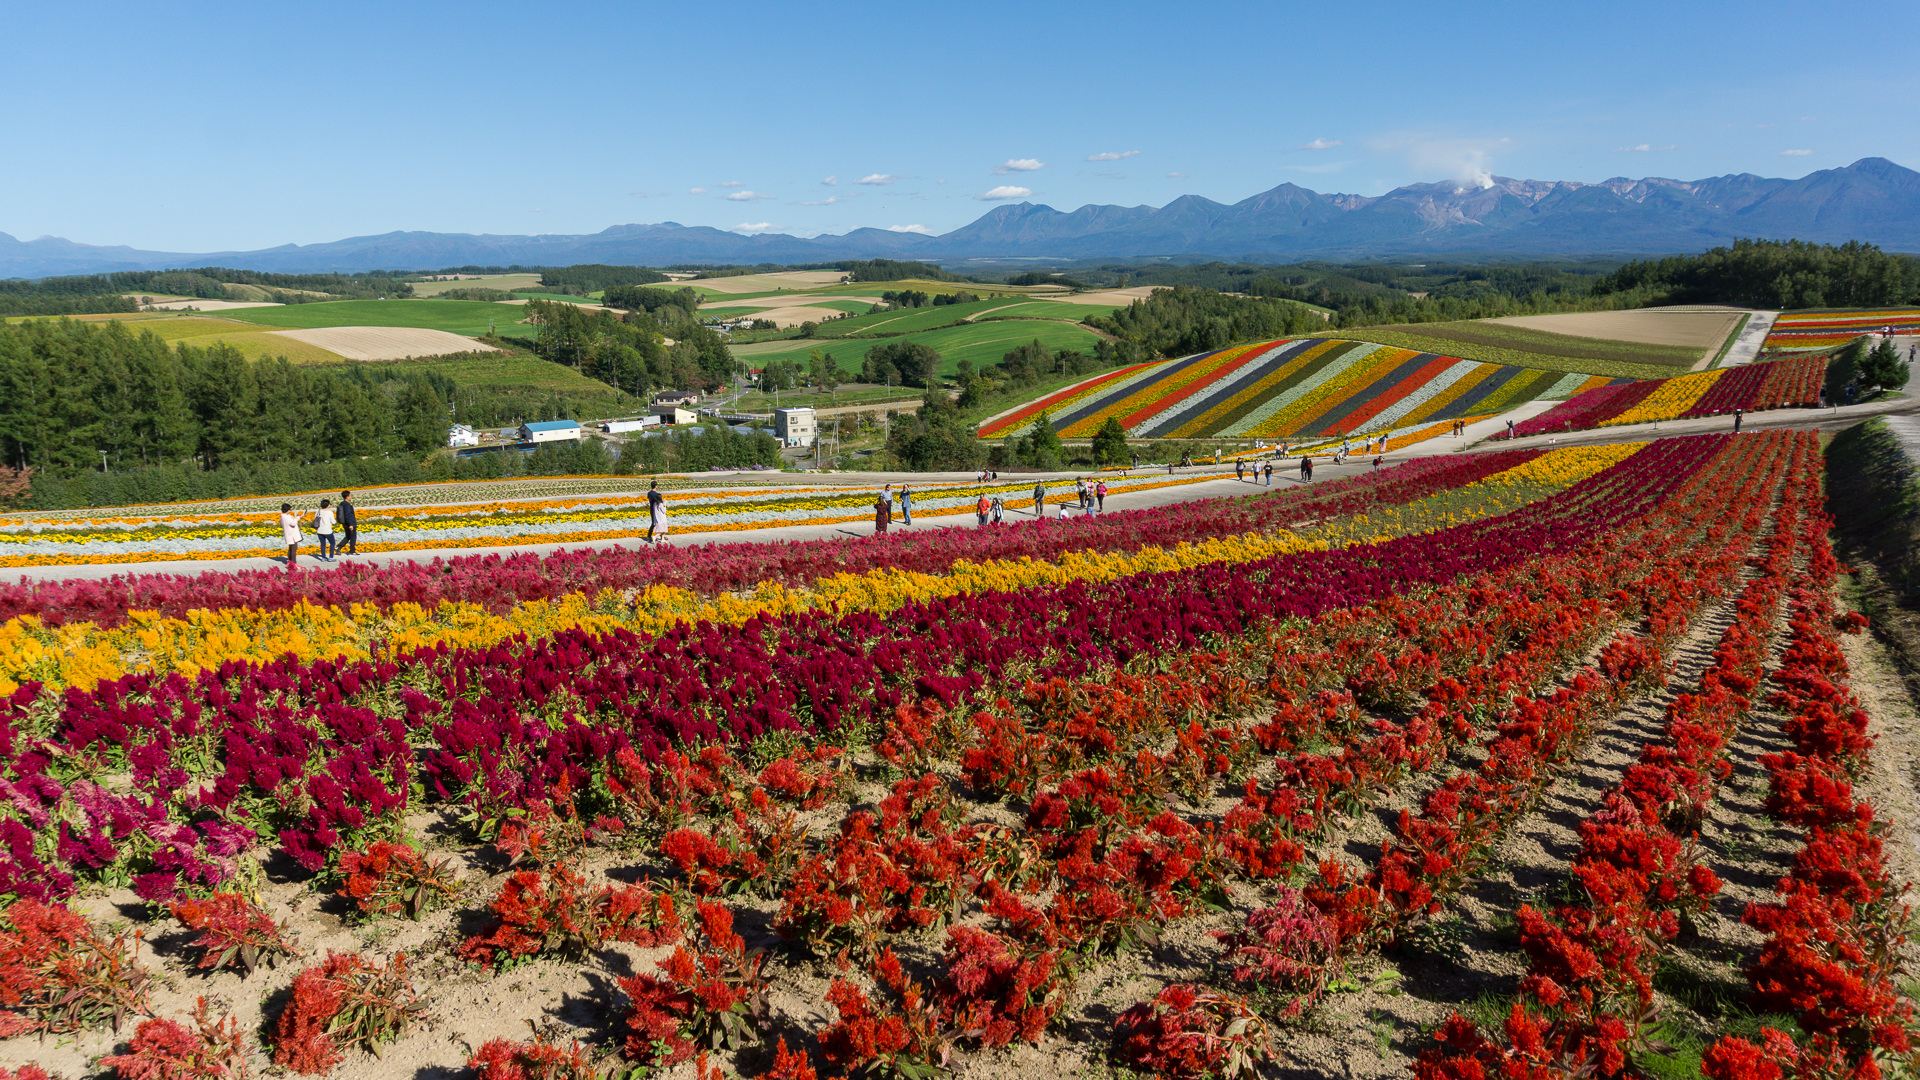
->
0 0 1920 252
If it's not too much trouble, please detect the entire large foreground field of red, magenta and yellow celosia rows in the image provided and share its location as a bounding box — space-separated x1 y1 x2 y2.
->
0 428 1916 1080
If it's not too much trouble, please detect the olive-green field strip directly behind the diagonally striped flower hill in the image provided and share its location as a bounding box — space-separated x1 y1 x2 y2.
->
1313 321 1699 379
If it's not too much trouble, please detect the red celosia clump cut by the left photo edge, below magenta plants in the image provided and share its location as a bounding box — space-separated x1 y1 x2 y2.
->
0 897 148 1038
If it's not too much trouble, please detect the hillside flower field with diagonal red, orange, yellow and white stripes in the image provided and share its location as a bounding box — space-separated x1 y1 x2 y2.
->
979 338 1613 440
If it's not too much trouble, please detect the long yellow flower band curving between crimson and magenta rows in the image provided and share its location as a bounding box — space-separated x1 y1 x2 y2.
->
0 444 1644 694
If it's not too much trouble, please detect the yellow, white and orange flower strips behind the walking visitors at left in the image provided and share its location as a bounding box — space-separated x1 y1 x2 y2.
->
0 473 1206 567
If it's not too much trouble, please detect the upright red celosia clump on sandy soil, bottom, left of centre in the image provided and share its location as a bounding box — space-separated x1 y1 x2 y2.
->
620 901 768 1065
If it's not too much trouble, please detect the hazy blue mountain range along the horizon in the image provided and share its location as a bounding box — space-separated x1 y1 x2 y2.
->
0 158 1920 277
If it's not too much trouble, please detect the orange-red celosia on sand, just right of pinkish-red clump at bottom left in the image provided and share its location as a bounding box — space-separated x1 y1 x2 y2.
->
273 953 426 1074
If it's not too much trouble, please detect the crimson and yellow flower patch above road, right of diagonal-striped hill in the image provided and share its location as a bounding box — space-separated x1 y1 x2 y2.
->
1513 354 1826 436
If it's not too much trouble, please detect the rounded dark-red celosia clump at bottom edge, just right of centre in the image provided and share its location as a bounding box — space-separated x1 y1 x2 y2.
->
1114 984 1273 1080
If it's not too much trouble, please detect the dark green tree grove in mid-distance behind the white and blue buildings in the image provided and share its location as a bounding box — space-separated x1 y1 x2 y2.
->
526 288 733 398
